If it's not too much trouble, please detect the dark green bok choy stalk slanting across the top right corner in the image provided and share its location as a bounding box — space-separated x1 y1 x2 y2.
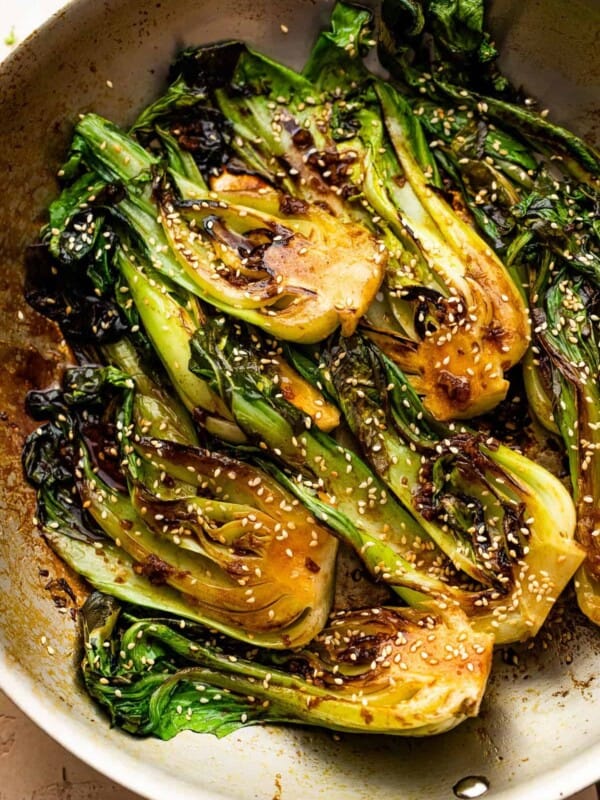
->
379 0 600 175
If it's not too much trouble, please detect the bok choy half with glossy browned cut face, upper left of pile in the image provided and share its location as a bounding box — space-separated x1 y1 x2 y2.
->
72 114 385 342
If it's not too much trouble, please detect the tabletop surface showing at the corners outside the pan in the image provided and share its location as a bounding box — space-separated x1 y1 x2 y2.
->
0 0 596 800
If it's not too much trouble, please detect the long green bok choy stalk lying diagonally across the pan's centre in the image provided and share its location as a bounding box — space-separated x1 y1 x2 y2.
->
190 317 462 603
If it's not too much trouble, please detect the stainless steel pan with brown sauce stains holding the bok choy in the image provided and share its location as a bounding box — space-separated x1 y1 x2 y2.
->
0 0 600 800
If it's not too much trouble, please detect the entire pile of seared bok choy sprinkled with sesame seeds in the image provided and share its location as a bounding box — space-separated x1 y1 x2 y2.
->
23 0 600 738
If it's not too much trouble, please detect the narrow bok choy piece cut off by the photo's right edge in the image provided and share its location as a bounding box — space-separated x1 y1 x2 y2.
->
520 208 600 624
